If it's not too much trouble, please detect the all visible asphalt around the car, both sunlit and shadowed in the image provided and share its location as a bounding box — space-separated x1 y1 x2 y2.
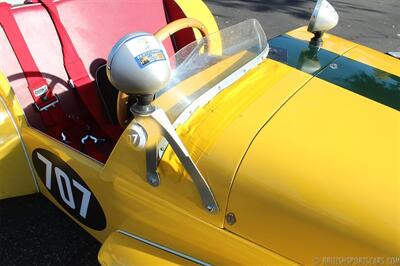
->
0 0 400 265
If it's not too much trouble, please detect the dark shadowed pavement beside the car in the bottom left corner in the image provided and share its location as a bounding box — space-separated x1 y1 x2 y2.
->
0 194 101 266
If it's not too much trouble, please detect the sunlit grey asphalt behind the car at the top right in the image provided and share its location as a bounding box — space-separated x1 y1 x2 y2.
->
204 0 400 52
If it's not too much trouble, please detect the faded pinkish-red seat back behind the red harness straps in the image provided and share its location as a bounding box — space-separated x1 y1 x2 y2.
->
0 0 173 129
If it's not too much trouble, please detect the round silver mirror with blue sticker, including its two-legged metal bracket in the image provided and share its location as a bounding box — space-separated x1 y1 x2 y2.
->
107 32 219 214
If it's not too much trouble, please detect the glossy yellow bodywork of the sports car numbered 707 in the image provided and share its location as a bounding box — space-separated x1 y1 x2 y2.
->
0 1 400 265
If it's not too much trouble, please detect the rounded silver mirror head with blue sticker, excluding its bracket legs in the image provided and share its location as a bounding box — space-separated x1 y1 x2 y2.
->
107 32 171 108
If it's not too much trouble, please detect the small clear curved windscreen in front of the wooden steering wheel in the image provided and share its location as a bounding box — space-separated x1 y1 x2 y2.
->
155 19 268 121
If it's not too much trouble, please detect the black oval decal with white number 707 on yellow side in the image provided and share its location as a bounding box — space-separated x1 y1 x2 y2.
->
32 149 106 230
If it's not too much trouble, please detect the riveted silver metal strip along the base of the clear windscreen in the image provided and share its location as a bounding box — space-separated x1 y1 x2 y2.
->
159 43 269 156
